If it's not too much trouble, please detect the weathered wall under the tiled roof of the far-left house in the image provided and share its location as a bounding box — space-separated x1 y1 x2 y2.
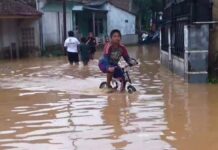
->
0 19 40 58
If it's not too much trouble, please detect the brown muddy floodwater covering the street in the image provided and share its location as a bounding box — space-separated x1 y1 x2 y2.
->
0 46 218 150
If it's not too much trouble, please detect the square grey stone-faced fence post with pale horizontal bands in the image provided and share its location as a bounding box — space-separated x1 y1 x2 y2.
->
184 24 209 83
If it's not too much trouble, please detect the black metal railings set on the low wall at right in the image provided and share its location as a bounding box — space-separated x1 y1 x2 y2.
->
161 0 211 58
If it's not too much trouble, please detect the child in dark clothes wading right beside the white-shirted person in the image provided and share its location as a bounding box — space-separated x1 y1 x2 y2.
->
80 37 90 66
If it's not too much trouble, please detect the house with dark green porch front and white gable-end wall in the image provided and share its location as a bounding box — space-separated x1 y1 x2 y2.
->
73 0 136 36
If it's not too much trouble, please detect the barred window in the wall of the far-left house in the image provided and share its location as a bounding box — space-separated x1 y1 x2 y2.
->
21 28 35 48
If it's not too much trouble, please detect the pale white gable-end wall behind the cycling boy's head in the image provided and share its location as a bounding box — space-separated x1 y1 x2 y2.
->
105 3 136 35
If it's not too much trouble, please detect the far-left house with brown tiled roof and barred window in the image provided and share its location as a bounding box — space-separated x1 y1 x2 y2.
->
0 0 42 58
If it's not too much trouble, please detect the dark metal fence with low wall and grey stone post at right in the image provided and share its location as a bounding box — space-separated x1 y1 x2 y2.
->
160 0 211 83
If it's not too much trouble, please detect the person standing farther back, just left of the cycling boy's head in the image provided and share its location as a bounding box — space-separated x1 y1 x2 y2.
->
86 32 97 59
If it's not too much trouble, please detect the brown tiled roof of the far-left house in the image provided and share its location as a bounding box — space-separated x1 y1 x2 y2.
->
0 0 42 18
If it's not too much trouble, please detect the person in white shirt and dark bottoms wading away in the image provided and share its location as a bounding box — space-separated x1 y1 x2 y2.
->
64 31 80 65
